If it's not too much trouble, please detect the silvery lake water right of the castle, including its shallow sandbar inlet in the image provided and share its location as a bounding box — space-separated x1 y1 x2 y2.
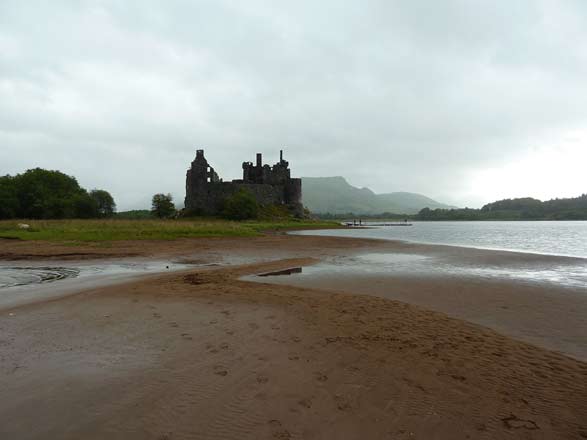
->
300 221 587 289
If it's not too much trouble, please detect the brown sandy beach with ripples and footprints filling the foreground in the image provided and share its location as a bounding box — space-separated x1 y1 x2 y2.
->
0 234 587 440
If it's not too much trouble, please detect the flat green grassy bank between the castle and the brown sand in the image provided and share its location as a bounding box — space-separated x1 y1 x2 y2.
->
0 219 338 243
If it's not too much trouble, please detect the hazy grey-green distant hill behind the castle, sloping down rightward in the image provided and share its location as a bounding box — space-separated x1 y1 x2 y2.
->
302 176 453 215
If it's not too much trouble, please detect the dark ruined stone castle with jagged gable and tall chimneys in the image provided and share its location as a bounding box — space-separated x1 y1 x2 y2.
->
185 150 303 217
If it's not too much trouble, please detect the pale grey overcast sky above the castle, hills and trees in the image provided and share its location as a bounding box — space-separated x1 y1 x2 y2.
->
0 0 587 210
